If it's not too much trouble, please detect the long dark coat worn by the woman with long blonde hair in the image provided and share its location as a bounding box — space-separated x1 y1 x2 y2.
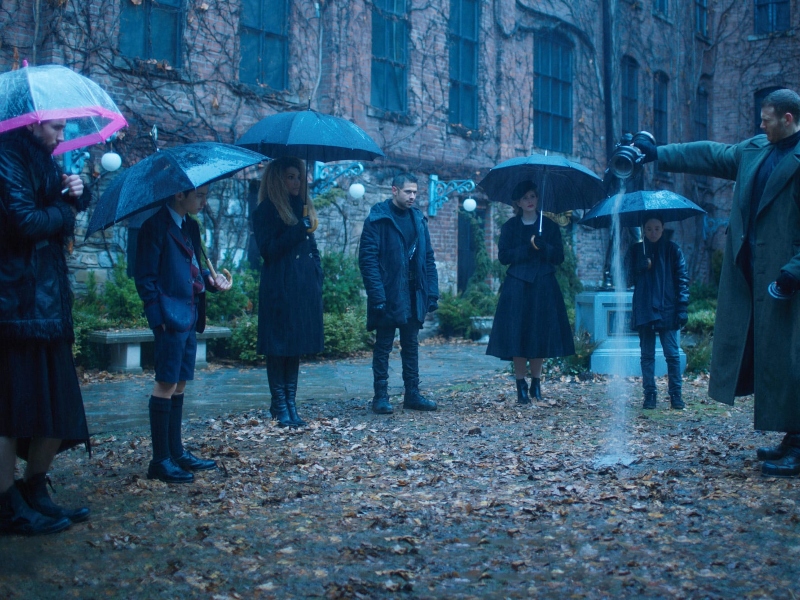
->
253 198 324 356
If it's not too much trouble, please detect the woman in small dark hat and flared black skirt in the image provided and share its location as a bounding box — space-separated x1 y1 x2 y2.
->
486 181 575 404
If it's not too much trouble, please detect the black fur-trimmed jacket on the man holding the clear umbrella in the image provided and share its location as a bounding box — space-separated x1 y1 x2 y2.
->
0 128 90 341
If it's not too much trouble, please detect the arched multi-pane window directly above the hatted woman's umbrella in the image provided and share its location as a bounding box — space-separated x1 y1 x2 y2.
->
533 33 572 154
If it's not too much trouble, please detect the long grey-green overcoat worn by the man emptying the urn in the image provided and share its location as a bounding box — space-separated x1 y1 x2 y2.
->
658 135 800 431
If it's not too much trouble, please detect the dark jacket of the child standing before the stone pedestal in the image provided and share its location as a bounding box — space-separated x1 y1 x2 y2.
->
625 236 689 330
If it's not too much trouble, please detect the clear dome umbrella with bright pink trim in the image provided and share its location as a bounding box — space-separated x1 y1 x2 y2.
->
0 65 128 154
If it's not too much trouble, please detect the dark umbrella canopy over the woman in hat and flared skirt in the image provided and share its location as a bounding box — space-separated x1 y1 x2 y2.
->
478 154 605 213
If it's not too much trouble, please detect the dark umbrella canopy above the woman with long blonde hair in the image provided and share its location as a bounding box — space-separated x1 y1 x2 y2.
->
236 110 383 162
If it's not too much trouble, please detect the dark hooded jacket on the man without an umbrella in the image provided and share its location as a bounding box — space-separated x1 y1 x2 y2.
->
358 198 439 331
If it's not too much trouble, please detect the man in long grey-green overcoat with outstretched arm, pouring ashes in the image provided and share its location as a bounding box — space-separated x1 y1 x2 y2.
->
637 89 800 477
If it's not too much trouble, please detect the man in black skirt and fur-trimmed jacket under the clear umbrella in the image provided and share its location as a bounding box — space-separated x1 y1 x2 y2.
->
0 119 90 535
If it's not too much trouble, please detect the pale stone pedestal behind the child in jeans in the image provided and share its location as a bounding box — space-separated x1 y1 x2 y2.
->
575 292 686 377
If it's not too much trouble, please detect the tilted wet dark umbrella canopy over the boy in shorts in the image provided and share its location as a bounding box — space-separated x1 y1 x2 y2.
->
86 142 265 237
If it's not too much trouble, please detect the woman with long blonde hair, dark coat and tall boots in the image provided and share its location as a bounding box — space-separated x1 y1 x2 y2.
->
253 156 323 427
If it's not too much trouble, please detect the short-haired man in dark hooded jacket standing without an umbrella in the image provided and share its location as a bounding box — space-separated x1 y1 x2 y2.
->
358 173 439 415
